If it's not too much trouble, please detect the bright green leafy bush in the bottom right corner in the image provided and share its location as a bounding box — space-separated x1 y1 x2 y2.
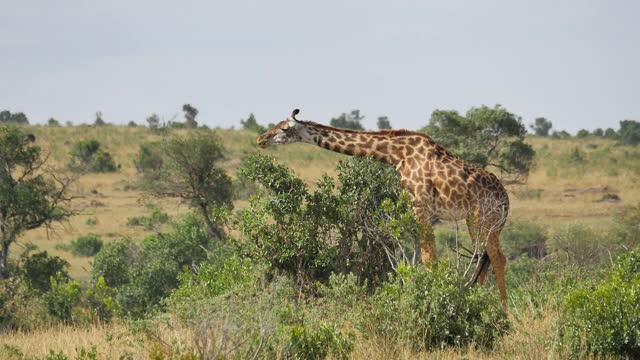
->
560 251 640 359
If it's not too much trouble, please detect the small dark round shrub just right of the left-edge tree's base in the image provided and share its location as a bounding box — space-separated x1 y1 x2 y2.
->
22 251 69 292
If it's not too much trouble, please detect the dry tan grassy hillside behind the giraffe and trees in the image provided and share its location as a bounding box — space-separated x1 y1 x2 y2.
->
13 126 640 280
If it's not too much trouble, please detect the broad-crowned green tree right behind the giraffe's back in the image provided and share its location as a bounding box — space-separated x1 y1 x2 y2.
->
422 105 535 180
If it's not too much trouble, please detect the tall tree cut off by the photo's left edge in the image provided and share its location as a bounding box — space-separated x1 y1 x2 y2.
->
0 126 75 276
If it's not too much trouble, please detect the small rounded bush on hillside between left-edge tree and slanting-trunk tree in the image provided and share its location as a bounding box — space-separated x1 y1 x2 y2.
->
68 140 118 172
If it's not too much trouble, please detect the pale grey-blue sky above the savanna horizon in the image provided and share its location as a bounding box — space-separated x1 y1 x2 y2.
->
0 0 640 132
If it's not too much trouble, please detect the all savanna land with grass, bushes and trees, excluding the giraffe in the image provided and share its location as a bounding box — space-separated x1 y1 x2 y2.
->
0 104 640 359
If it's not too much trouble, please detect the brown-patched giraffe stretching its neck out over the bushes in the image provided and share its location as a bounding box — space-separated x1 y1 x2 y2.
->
257 109 509 309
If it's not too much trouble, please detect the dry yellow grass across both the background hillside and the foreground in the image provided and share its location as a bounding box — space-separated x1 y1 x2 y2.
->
0 126 640 359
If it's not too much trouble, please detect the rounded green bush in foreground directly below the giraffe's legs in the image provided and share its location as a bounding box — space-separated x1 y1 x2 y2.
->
361 262 509 351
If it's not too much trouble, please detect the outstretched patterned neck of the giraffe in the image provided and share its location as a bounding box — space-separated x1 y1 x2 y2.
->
303 122 401 166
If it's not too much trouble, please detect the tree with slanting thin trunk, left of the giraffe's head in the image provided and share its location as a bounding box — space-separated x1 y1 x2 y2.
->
140 131 233 239
